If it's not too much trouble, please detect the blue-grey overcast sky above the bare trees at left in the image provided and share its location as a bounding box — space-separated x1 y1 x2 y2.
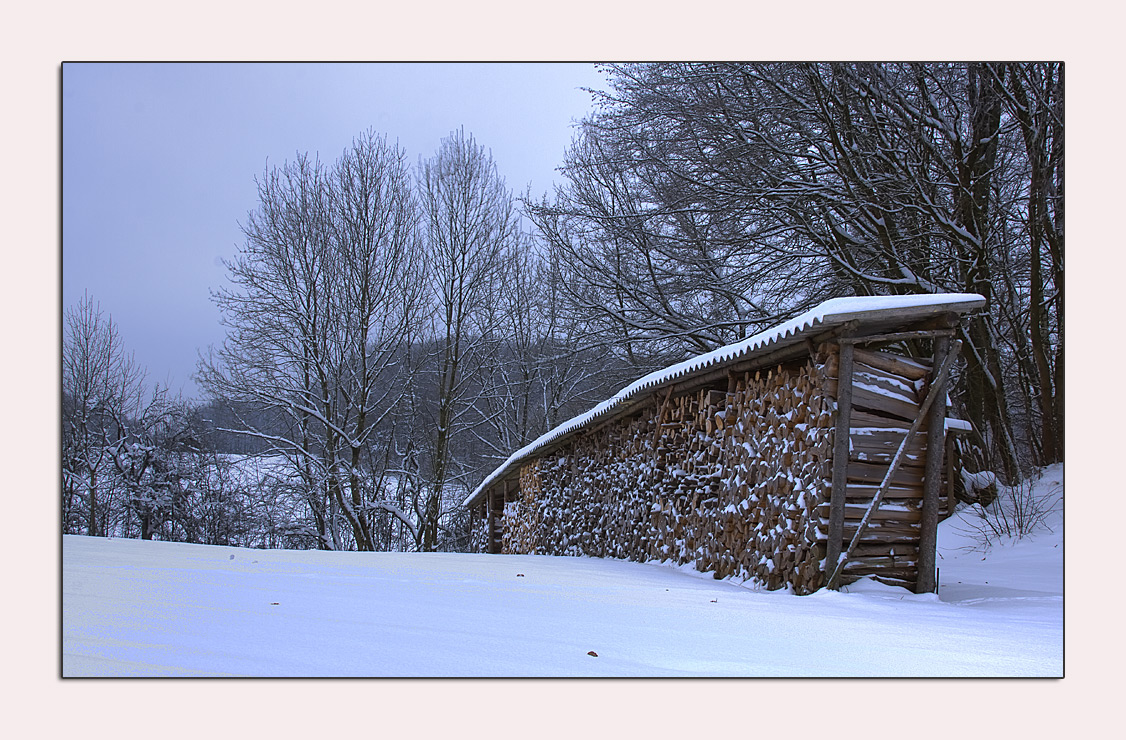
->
62 63 604 396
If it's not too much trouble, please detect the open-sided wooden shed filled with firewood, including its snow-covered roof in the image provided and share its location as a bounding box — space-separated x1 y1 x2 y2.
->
464 294 984 594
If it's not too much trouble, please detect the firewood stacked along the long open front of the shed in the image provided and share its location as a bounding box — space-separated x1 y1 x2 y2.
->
504 354 834 592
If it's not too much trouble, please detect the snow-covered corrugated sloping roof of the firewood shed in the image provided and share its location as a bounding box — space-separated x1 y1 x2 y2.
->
462 293 985 507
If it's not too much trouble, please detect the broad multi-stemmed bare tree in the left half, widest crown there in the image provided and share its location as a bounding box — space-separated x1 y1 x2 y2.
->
199 132 421 550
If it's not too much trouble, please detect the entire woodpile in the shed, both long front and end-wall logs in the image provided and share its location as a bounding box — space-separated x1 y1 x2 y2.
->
474 342 946 594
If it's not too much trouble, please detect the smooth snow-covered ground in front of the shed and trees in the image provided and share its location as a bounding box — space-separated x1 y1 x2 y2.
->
62 467 1063 677
